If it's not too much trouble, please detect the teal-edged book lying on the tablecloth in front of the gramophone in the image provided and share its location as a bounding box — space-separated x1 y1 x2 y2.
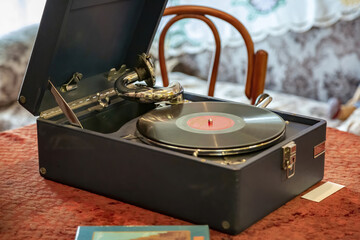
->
75 225 210 240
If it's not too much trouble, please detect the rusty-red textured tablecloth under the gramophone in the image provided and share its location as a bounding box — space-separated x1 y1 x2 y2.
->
0 125 360 239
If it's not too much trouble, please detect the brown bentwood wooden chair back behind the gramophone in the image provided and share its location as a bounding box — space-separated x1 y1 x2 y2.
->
159 5 268 104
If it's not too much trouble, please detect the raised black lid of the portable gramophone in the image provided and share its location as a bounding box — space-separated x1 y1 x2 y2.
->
19 0 167 115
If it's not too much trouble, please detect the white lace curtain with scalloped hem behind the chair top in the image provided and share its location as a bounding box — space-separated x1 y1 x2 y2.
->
160 0 360 55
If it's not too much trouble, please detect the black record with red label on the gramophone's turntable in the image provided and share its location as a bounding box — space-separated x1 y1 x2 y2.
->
137 102 285 155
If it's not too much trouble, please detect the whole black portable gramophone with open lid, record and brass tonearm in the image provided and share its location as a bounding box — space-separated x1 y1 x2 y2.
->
19 0 326 234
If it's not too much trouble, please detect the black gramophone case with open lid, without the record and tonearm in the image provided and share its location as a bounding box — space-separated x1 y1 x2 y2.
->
19 0 326 234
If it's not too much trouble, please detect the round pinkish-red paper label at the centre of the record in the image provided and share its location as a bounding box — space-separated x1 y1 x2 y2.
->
186 115 235 131
